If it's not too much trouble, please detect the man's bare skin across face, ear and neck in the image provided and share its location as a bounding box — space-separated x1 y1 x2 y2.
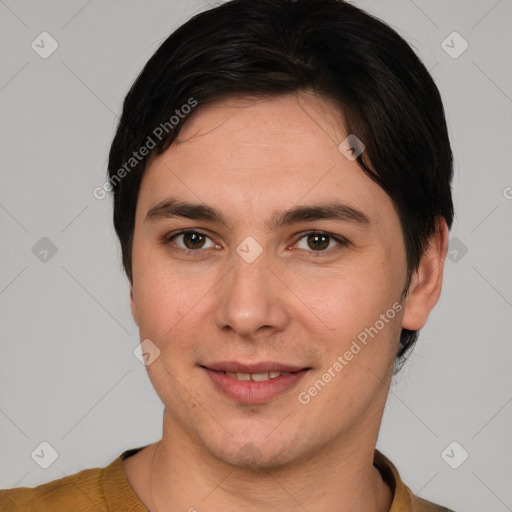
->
123 92 448 512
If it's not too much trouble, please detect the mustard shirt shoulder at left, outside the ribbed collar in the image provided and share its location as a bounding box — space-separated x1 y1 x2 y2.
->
0 461 115 512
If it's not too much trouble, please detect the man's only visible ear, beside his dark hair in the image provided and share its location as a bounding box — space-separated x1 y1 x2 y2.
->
402 217 448 331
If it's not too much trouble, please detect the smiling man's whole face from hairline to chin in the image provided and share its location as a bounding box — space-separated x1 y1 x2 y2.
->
132 93 406 467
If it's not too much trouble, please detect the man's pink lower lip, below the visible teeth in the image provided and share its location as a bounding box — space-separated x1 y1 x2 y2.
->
203 368 308 404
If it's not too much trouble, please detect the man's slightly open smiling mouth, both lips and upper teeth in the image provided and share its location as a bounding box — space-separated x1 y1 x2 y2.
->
200 362 311 404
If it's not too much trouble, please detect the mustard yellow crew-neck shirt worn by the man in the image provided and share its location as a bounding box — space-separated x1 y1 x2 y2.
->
0 447 453 512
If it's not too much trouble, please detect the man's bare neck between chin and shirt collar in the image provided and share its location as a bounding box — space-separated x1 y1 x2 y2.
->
149 411 392 512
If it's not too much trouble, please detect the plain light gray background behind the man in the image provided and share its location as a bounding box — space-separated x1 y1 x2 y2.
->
0 0 512 512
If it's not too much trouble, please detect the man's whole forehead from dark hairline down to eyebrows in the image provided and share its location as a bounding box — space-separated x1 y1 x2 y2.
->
139 93 391 228
